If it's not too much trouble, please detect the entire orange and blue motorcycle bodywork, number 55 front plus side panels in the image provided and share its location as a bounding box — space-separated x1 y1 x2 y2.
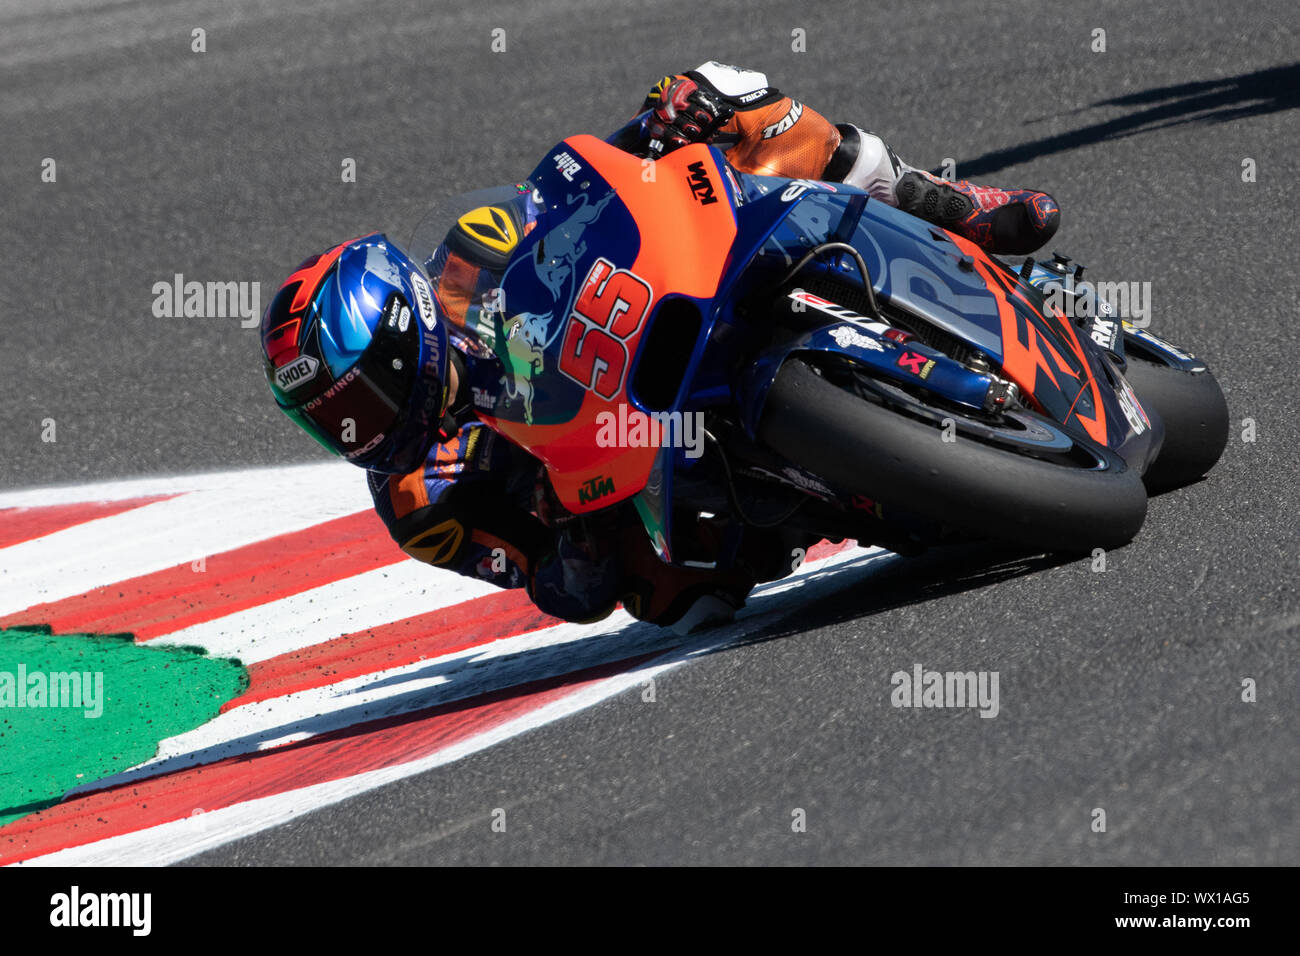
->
441 135 1158 558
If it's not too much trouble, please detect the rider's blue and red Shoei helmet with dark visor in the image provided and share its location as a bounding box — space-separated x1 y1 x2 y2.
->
261 233 447 475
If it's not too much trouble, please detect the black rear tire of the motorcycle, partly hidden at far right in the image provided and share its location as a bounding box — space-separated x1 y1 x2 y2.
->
1125 352 1227 494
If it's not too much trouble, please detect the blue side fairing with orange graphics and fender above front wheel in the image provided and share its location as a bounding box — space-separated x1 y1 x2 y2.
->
706 176 1160 467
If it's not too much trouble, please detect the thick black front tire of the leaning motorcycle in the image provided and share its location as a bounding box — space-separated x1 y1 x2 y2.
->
759 358 1147 551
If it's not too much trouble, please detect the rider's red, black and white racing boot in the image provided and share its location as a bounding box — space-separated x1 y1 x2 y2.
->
824 124 1061 255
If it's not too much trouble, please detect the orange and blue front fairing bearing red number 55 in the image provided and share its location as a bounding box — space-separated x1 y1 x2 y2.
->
449 135 736 514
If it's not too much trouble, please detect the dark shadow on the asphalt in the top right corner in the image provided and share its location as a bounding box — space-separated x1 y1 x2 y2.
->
936 64 1300 178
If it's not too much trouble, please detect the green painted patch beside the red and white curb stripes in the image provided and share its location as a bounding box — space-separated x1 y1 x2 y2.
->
0 627 248 826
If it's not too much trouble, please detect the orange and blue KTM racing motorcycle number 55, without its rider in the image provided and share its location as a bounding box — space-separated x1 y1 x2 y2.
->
411 135 1227 568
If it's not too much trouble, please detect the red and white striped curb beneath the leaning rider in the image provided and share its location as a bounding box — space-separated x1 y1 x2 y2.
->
0 463 884 865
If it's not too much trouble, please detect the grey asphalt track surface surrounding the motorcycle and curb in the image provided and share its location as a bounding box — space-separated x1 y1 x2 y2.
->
0 0 1300 865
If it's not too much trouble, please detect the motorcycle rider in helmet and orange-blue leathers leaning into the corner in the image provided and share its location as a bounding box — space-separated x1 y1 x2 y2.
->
261 61 1060 631
